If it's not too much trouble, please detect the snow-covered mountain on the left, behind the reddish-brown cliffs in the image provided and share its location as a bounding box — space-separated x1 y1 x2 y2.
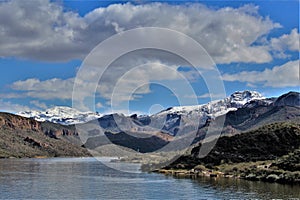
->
17 106 101 125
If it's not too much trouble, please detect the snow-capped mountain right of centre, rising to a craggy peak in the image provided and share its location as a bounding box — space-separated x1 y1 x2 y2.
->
151 90 272 134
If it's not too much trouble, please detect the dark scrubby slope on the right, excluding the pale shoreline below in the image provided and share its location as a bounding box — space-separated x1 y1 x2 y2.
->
164 123 300 169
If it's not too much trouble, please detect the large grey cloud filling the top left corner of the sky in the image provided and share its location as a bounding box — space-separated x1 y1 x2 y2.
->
0 0 88 61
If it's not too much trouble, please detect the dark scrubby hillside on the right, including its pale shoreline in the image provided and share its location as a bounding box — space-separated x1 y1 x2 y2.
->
155 122 300 183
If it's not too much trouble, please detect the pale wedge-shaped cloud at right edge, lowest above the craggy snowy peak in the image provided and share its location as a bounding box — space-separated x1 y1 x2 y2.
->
223 60 300 88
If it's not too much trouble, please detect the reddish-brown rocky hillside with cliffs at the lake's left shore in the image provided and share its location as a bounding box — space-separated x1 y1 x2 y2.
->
0 113 90 158
